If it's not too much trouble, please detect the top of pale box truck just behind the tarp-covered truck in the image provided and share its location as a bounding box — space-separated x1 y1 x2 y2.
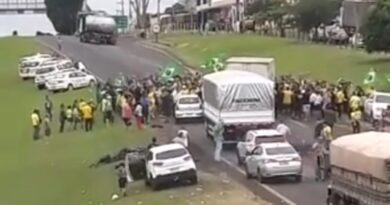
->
225 57 276 81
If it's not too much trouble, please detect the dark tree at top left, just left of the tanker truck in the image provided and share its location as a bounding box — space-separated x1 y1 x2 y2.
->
45 0 84 35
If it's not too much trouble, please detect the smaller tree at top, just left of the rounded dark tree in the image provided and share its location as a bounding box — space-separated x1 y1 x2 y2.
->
246 0 288 36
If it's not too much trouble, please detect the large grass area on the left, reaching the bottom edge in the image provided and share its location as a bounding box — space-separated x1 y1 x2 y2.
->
0 38 267 205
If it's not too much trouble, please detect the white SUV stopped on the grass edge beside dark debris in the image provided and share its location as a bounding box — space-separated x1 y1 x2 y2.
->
145 143 198 190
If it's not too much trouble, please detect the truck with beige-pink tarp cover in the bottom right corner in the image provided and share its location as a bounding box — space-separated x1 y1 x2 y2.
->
327 132 390 205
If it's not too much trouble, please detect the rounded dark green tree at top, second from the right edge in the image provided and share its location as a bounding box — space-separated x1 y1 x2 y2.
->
292 0 341 32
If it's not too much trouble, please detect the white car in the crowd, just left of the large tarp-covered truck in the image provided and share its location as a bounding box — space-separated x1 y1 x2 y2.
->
174 94 203 122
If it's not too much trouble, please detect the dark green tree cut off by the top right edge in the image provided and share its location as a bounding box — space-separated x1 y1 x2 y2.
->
363 0 390 53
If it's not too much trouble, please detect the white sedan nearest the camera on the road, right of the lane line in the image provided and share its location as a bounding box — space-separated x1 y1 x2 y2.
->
245 142 303 182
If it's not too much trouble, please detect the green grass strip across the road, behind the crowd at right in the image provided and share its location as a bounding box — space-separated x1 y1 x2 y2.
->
164 35 390 87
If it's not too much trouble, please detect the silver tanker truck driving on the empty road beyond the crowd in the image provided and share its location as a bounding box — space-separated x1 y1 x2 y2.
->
79 15 118 45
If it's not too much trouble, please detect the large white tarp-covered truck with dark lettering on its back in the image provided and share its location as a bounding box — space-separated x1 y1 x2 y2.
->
202 70 275 144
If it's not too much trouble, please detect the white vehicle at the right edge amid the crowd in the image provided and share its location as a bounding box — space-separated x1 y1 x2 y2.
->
364 92 390 120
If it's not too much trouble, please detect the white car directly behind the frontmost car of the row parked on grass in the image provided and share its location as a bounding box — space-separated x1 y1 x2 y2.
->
34 60 76 89
